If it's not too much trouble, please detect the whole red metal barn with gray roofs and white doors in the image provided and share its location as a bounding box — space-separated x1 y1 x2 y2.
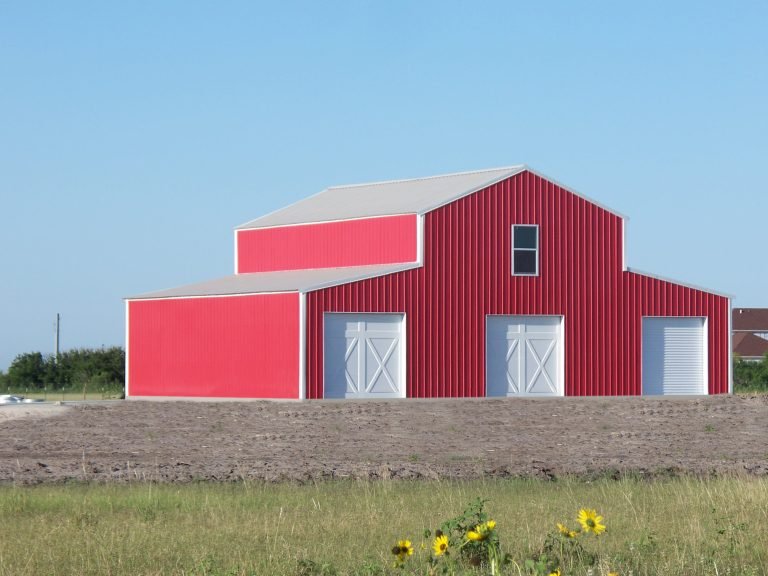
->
126 166 731 398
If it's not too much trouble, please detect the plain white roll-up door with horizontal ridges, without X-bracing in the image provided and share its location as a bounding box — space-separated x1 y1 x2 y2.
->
642 317 707 394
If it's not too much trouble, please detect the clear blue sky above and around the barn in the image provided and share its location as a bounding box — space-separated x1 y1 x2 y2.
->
0 0 768 370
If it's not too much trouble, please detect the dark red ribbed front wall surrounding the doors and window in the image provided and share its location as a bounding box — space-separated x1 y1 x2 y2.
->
307 172 728 398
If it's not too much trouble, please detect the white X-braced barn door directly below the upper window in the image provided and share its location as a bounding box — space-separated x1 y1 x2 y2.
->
486 316 563 396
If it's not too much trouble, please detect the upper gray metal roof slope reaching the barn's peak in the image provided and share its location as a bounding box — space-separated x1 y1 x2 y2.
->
236 165 527 230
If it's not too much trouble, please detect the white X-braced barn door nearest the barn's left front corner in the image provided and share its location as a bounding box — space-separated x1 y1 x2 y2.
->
324 314 405 398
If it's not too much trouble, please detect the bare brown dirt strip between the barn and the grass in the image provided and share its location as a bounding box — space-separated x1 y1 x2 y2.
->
0 396 768 484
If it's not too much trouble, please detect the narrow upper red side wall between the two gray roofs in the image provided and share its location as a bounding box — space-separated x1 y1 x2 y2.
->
237 214 418 274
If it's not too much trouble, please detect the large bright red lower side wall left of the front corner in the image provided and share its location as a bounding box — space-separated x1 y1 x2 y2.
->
128 294 299 398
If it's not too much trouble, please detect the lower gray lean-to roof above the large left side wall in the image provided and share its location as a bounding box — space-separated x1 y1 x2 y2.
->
126 262 421 300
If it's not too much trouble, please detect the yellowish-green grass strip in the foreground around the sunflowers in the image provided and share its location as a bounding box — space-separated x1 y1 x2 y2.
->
0 478 768 576
